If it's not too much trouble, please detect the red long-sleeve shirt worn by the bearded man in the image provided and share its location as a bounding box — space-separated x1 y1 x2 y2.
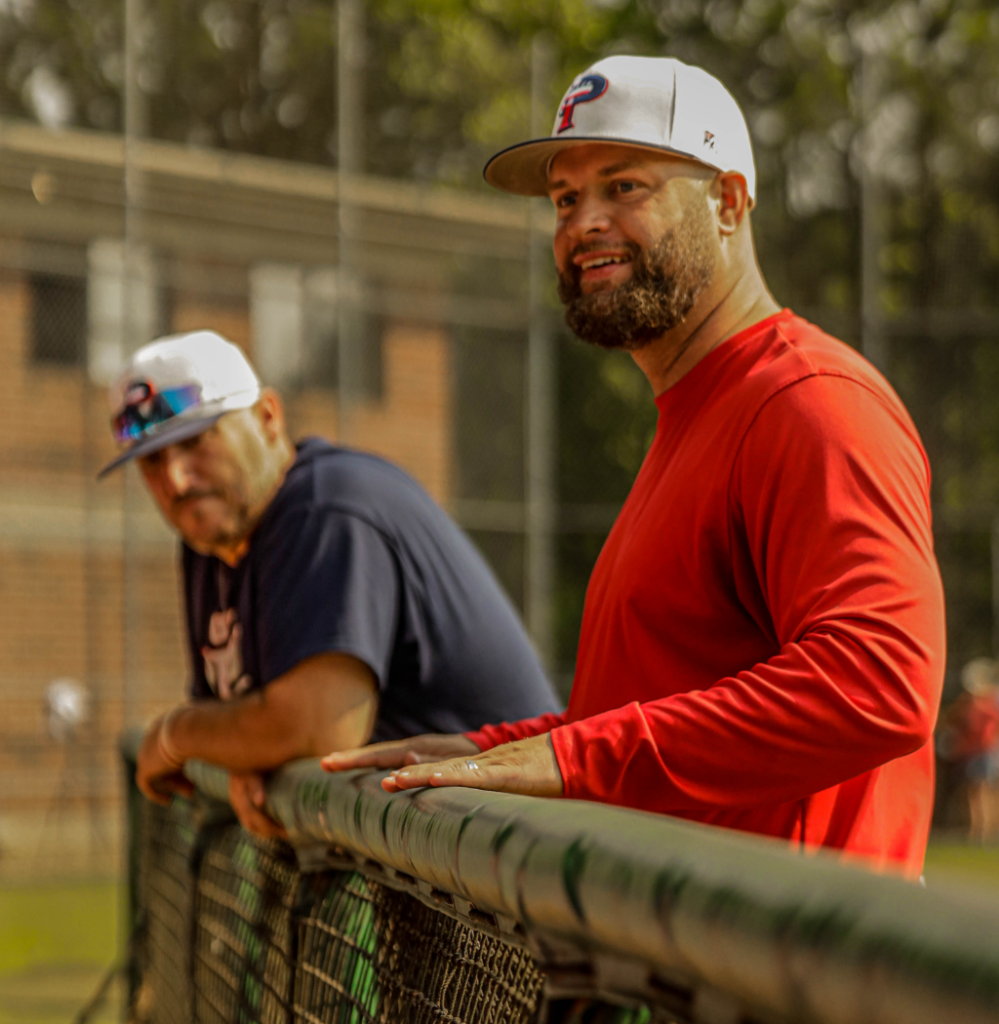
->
469 310 945 876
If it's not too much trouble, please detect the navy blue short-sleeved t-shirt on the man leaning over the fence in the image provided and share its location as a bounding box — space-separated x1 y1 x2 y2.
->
183 438 558 741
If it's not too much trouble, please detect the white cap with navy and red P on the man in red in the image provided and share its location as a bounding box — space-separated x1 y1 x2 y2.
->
484 56 756 202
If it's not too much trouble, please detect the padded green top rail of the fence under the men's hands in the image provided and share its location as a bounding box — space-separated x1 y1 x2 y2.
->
123 732 999 1024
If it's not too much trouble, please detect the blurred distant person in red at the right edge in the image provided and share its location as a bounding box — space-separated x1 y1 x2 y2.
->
938 657 999 843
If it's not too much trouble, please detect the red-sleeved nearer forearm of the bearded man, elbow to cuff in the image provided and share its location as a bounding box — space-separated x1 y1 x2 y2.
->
552 634 942 813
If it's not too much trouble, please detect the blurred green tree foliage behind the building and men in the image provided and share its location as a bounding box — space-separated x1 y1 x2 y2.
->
0 0 999 679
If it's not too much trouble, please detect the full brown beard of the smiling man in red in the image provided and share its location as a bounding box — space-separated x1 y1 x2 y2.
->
559 206 714 352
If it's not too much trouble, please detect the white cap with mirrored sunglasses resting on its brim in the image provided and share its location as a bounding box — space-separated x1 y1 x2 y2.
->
97 331 261 479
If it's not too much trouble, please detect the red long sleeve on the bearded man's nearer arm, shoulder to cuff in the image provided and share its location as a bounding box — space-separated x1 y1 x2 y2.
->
552 376 945 812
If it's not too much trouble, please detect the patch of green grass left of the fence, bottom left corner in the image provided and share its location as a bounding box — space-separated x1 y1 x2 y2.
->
0 882 121 1024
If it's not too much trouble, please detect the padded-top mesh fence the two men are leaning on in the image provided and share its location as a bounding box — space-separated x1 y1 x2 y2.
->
125 737 999 1024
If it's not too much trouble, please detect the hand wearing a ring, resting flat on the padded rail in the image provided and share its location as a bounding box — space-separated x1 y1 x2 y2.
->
382 733 565 797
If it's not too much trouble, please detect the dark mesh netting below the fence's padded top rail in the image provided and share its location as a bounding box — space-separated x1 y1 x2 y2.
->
130 800 691 1024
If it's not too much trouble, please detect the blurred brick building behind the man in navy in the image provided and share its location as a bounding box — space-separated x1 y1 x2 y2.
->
0 117 540 882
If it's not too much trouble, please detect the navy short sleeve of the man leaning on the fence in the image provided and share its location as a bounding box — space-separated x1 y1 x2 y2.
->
254 507 400 688
